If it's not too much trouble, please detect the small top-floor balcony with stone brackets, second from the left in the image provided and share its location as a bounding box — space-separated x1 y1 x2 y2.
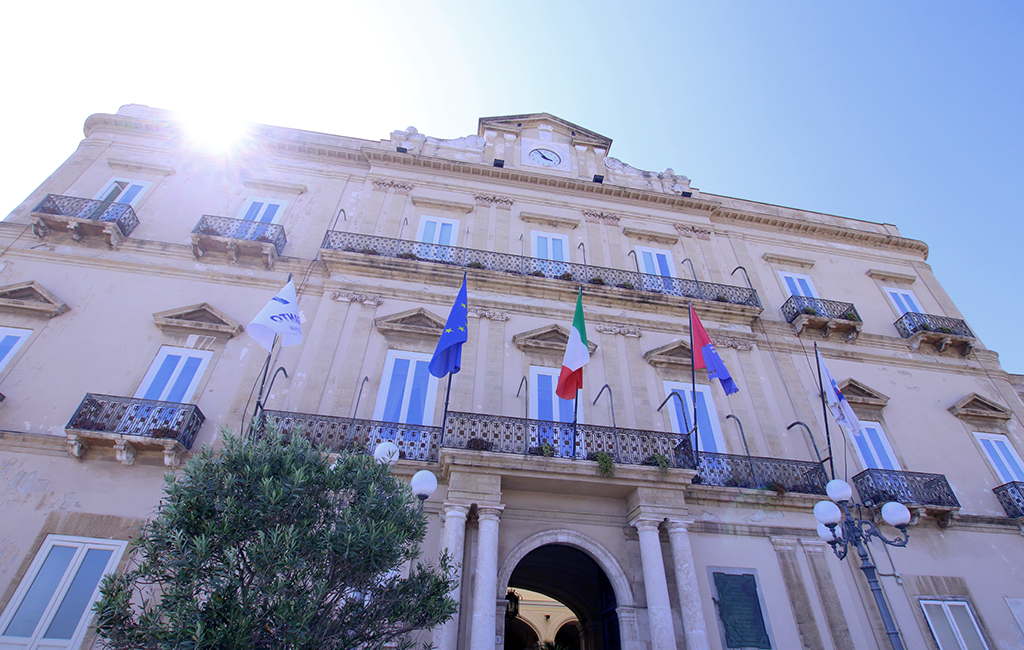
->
191 214 288 269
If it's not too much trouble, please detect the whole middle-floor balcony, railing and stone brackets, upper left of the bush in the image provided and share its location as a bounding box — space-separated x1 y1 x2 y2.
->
65 393 206 467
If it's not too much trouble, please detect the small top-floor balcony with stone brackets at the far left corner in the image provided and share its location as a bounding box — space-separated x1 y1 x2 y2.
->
32 194 138 249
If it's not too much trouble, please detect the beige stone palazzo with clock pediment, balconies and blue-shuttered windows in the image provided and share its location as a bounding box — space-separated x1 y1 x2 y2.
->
0 105 1024 650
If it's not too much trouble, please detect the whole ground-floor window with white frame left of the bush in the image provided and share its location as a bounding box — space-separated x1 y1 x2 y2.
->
0 535 128 649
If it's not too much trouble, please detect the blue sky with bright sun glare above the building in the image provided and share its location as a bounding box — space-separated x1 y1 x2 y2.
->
0 0 1024 373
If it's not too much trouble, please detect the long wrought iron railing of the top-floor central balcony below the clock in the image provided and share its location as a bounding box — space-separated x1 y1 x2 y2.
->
321 230 761 307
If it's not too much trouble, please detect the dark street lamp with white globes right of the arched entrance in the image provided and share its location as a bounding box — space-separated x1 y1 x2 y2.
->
814 479 910 650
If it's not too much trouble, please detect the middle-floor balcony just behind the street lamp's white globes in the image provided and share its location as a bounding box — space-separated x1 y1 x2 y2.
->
853 470 959 527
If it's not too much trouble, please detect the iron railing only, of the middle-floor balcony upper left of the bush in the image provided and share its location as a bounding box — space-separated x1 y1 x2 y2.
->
66 393 206 449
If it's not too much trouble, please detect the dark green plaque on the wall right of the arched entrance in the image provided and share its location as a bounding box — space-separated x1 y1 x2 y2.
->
709 568 772 650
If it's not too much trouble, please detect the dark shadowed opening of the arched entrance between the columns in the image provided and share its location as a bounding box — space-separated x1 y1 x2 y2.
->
505 544 622 650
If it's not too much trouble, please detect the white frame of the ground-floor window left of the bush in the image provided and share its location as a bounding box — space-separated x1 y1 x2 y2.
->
0 534 128 650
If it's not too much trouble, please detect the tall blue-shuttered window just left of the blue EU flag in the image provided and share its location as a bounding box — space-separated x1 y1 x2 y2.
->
374 350 437 427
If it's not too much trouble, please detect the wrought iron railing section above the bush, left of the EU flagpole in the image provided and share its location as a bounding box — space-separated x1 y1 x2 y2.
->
261 410 441 462
